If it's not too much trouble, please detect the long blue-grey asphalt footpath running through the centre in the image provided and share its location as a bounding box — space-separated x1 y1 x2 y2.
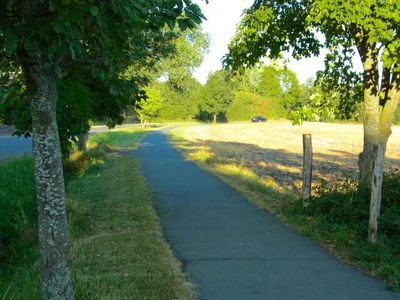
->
135 133 400 300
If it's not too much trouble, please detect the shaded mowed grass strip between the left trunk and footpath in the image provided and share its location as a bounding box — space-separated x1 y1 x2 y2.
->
68 154 193 299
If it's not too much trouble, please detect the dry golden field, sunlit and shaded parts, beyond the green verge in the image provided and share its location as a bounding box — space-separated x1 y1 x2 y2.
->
179 121 400 192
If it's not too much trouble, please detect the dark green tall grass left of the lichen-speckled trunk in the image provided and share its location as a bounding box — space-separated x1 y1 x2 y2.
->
0 157 40 299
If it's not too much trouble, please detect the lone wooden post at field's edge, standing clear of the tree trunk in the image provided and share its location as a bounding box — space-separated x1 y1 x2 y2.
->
301 134 312 206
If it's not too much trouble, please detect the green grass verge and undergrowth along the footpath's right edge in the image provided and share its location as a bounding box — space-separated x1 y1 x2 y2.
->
170 128 400 290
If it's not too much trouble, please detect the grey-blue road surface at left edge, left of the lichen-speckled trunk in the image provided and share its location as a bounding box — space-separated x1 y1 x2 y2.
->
0 136 32 160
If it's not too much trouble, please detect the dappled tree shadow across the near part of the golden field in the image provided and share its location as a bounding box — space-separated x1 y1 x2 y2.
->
174 140 400 193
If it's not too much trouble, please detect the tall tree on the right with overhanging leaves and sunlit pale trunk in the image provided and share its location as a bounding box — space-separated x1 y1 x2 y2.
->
224 0 400 187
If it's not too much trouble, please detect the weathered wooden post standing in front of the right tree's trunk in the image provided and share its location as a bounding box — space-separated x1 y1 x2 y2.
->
368 145 384 243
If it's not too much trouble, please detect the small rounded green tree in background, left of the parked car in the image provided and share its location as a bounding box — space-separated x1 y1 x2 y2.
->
200 71 234 121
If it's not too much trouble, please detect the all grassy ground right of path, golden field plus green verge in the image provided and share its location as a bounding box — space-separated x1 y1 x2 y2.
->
170 121 400 290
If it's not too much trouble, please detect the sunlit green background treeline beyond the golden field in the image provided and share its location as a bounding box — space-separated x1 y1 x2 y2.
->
140 30 400 124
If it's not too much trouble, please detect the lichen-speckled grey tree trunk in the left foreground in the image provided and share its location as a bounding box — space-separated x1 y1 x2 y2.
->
19 51 74 299
